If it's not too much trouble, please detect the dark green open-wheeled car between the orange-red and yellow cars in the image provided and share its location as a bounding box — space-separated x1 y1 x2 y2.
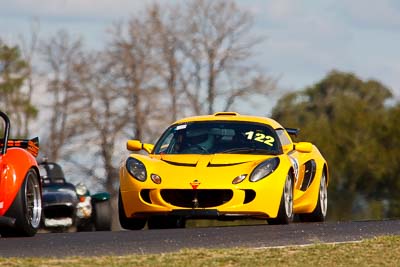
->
39 161 111 232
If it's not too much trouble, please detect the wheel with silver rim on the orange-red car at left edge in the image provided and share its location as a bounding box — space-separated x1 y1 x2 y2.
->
2 169 42 237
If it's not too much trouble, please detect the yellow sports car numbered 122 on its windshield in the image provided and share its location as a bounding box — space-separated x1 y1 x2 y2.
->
118 112 329 230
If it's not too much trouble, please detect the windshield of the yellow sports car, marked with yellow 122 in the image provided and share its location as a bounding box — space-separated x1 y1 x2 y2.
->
154 121 281 155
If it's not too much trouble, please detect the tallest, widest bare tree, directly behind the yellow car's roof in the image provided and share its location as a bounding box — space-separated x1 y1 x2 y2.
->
183 0 275 114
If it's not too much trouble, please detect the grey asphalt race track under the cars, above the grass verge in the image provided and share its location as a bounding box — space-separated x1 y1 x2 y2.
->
0 220 400 257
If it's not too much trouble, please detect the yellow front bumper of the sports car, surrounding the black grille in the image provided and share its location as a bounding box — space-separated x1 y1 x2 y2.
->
120 166 288 221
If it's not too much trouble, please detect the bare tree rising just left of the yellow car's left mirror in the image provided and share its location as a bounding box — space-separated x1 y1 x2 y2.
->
75 53 130 196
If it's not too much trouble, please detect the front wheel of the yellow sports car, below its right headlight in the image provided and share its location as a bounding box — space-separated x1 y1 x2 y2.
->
267 174 293 224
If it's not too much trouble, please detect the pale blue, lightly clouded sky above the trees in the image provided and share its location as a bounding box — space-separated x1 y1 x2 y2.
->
0 0 400 104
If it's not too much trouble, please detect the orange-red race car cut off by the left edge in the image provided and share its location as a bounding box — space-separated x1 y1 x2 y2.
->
0 111 42 237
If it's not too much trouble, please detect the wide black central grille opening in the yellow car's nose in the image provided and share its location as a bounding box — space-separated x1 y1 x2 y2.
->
161 189 233 208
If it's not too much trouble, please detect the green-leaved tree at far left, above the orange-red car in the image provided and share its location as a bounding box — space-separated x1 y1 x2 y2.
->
0 40 38 137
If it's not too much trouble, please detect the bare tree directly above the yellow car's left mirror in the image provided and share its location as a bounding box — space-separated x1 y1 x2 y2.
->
108 18 159 139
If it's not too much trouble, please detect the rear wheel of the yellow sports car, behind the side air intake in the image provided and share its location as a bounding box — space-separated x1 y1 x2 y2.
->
299 172 328 222
